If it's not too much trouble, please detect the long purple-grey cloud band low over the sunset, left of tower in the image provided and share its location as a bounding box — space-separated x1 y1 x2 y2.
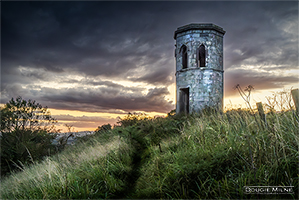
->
40 88 173 112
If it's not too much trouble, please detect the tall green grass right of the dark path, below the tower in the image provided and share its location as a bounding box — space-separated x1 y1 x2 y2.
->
136 110 299 199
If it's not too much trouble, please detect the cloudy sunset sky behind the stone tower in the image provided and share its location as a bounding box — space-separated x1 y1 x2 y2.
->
0 1 299 131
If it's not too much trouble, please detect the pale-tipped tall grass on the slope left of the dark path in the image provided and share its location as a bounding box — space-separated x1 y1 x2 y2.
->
1 132 132 199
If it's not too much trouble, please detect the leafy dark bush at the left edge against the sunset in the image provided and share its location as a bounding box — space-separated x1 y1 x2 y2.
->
0 97 56 176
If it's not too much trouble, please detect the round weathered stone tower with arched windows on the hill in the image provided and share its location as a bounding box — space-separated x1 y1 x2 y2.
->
174 24 225 113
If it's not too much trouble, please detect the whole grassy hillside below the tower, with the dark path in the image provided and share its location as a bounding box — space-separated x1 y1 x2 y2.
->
1 110 299 199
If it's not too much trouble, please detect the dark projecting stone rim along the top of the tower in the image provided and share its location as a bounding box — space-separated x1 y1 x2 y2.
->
174 23 225 39
